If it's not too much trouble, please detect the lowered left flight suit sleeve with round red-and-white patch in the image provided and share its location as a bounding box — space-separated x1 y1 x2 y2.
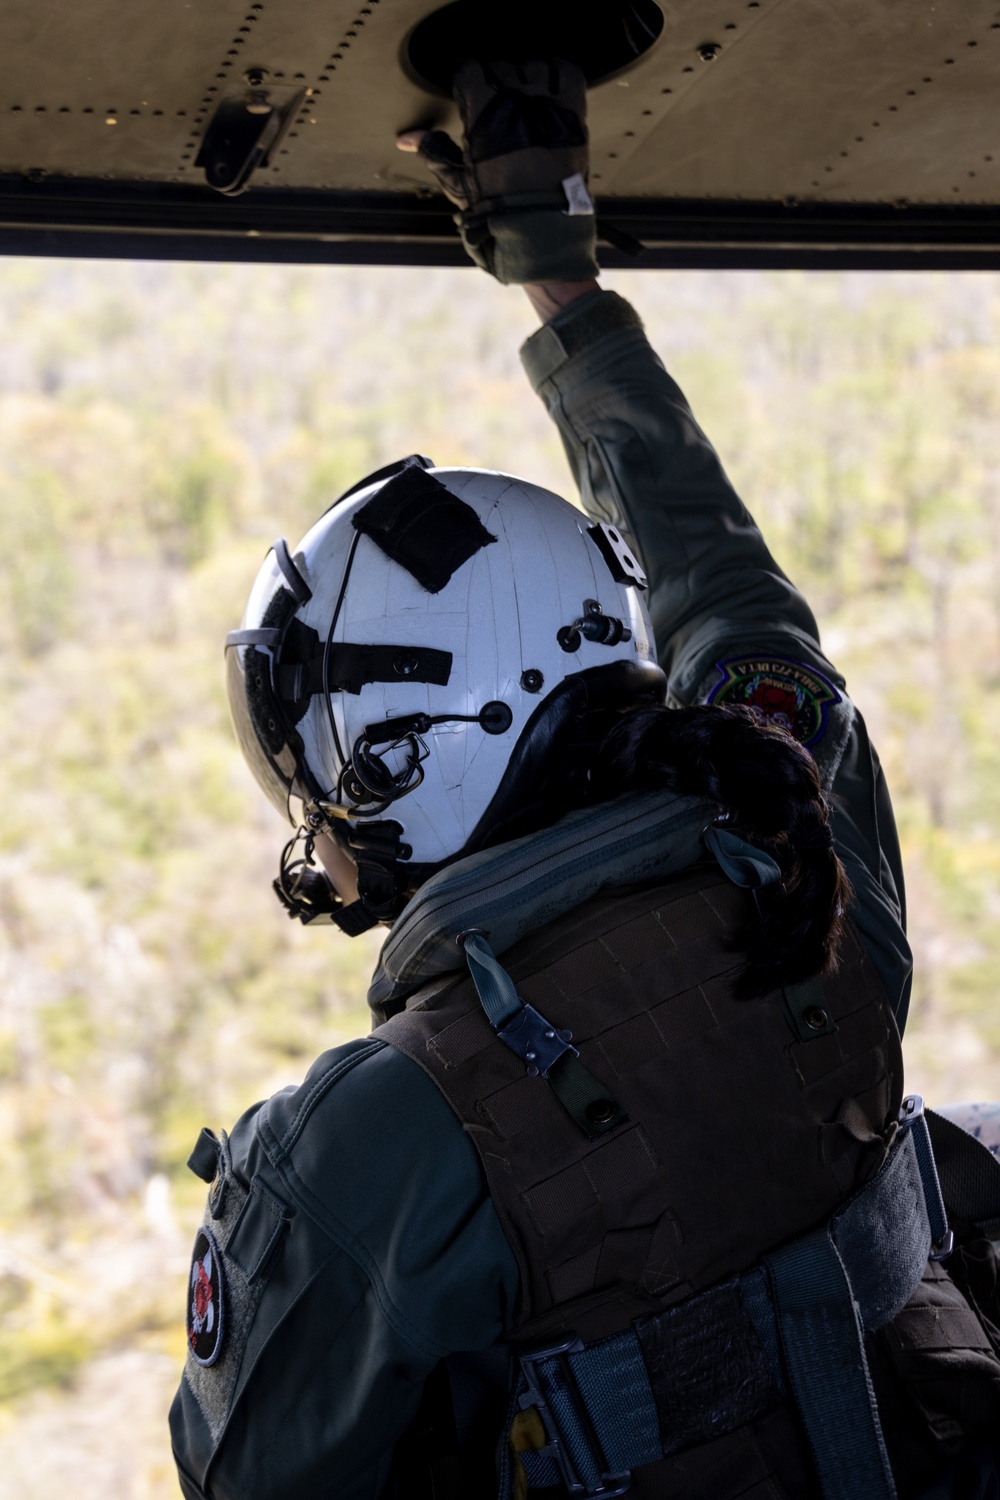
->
171 1038 519 1500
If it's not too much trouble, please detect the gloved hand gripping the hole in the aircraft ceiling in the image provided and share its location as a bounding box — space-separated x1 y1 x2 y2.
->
400 60 598 284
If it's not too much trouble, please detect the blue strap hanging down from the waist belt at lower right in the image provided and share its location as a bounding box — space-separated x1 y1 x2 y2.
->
766 1229 897 1500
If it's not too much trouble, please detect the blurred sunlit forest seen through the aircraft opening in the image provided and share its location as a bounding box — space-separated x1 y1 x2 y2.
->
0 260 1000 1500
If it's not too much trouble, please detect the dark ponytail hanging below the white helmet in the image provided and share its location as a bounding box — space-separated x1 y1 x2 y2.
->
591 705 852 998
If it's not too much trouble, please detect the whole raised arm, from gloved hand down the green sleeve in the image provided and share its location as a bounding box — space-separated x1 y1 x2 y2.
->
399 63 912 1026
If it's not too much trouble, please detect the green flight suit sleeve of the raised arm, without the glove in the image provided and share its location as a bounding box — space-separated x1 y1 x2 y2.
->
522 291 912 1028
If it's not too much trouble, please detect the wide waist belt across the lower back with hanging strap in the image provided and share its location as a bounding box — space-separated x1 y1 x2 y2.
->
501 1128 940 1500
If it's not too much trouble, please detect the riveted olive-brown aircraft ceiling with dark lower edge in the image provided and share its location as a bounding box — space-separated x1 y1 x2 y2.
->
0 0 1000 267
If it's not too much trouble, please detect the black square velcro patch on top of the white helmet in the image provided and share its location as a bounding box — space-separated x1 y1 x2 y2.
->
354 468 496 594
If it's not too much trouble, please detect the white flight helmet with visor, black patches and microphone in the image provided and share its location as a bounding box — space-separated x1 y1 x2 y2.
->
226 456 666 932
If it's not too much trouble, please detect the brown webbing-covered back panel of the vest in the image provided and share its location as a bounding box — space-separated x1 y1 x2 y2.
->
376 869 901 1341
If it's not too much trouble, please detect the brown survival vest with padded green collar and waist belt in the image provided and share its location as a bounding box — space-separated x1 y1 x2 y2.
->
373 797 1000 1500
